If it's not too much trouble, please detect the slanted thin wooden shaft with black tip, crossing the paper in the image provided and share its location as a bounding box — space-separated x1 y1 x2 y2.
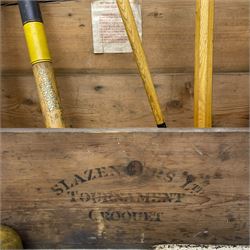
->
116 0 166 128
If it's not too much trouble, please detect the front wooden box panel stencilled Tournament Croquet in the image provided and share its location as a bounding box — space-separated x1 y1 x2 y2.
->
1 129 249 249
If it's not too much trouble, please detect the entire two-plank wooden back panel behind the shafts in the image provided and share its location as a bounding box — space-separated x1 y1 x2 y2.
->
0 0 249 128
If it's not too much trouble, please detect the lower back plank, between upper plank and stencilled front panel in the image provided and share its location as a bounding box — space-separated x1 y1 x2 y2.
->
1 74 249 128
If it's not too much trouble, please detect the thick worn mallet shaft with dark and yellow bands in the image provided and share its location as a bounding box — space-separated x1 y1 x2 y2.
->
18 0 65 128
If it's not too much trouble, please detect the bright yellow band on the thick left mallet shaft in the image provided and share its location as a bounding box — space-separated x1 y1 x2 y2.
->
23 22 51 64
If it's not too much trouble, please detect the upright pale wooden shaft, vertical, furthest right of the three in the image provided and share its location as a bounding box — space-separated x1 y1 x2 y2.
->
194 0 214 128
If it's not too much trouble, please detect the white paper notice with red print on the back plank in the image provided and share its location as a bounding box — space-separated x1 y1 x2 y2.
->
91 0 142 53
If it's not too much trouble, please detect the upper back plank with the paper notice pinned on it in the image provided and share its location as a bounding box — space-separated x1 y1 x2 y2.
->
1 0 249 72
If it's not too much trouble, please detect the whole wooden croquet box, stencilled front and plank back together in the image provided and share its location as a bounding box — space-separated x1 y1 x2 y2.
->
1 0 249 248
